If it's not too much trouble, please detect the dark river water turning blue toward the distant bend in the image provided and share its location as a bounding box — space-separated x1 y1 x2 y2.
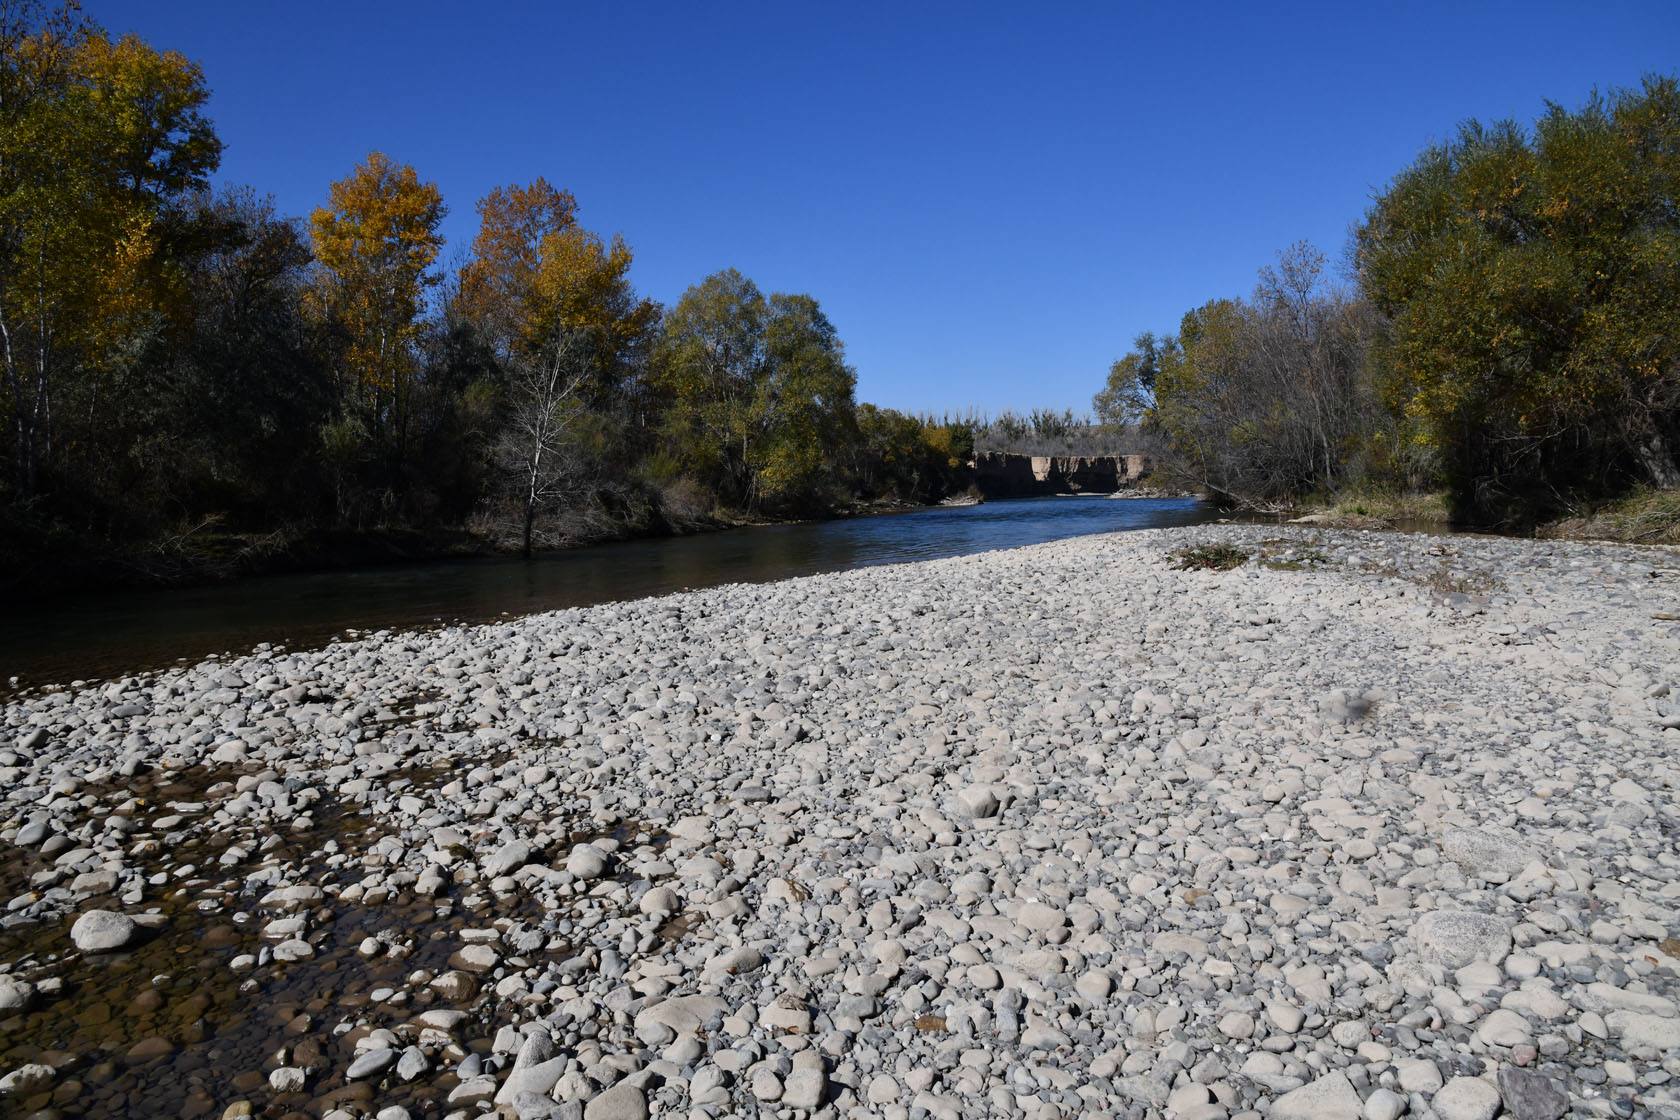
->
0 497 1213 688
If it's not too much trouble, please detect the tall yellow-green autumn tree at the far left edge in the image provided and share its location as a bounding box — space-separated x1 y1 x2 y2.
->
0 3 222 502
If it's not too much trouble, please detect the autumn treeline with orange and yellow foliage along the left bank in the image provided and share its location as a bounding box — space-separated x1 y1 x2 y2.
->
0 2 1122 579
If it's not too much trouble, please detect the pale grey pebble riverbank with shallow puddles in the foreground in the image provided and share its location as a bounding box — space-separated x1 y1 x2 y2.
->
0 526 1680 1120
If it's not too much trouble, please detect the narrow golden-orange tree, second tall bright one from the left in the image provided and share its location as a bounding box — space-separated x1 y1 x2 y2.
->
309 151 447 465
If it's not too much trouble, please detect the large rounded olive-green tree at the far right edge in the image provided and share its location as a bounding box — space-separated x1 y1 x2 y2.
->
1356 77 1680 516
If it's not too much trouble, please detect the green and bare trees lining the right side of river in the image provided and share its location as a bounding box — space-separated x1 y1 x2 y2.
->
1094 77 1680 527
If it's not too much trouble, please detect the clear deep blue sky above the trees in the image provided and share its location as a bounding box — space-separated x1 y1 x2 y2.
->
86 0 1680 411
